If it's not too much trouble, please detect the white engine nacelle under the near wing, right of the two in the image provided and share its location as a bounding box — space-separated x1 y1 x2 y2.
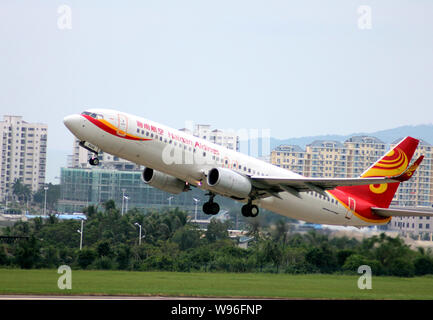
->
207 168 252 199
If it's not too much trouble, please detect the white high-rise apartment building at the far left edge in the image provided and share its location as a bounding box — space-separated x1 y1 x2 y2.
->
0 115 48 201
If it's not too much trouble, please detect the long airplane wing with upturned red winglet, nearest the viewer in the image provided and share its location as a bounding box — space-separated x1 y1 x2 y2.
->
250 156 424 197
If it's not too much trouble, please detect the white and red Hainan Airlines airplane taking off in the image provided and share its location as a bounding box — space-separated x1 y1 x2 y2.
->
63 109 433 227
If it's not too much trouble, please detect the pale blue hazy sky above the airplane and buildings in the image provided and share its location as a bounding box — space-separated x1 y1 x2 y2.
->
0 0 433 182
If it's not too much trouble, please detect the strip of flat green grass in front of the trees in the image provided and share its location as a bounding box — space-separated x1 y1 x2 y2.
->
0 269 433 299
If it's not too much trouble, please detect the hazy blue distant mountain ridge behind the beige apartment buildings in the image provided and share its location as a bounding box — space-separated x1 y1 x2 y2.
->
270 124 433 150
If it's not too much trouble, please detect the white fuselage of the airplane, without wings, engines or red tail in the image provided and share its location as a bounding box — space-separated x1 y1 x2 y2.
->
65 109 382 226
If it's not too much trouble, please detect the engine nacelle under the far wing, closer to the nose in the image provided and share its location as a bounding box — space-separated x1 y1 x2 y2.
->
141 168 188 194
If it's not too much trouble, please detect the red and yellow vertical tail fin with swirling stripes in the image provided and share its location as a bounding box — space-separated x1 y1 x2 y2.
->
337 137 419 208
